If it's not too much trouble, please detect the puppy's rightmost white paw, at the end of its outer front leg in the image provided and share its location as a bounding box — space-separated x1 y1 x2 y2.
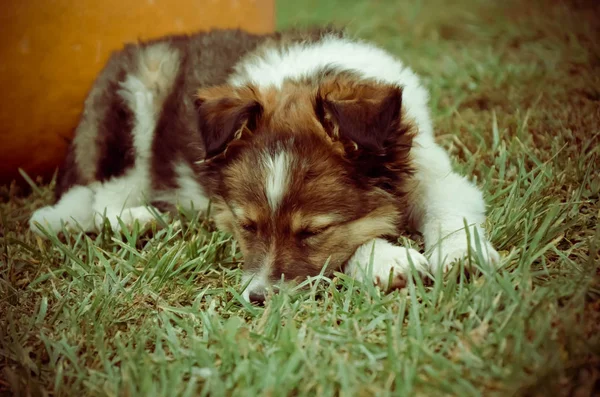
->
429 232 500 274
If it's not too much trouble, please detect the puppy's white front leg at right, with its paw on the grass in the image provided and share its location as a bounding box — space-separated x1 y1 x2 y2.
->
409 136 499 273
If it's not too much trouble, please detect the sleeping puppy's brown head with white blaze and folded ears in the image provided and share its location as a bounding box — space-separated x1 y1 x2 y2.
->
198 76 413 302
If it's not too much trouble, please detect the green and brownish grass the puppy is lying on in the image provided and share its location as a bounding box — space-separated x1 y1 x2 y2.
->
0 0 600 396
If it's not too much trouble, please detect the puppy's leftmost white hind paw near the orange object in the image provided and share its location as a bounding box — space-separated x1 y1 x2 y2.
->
29 186 94 236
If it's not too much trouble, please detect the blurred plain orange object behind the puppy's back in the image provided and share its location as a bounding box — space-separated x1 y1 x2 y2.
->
0 0 274 183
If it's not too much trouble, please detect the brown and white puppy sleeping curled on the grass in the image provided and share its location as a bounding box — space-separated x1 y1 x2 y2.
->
31 30 498 300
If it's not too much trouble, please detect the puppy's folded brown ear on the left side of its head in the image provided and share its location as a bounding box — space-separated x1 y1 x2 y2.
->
196 85 262 159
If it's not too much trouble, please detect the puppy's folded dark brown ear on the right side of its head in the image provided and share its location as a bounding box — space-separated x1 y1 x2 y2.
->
315 79 402 155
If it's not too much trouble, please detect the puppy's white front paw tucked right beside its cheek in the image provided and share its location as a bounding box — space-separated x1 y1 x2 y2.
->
346 239 428 290
